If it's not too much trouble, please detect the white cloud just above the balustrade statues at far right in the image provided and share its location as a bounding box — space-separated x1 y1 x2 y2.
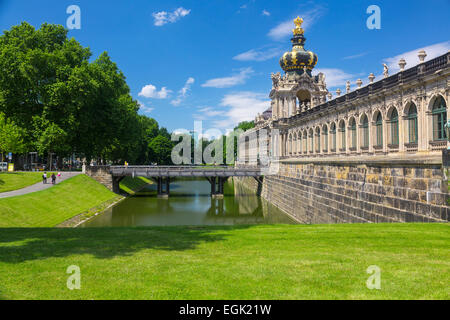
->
380 41 450 74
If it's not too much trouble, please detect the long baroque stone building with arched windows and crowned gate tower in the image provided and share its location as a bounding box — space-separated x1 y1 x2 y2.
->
237 18 450 223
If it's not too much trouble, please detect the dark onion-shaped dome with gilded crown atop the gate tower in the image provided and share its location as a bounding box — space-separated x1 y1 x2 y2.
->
280 17 318 76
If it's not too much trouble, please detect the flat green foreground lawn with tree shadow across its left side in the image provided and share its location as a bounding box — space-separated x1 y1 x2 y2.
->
0 224 450 299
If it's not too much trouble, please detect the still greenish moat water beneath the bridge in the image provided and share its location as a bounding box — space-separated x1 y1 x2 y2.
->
81 180 296 227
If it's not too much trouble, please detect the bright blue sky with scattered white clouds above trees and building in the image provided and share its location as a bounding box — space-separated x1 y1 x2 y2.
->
0 0 450 135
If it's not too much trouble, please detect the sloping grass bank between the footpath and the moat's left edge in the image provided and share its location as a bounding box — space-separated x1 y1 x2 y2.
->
0 175 116 227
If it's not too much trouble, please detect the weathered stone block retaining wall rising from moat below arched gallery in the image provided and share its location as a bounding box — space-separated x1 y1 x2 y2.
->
236 159 450 224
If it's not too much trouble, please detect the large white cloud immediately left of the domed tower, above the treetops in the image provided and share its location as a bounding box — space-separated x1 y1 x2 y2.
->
214 91 270 129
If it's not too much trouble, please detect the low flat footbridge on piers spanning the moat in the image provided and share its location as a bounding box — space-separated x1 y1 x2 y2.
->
83 165 263 197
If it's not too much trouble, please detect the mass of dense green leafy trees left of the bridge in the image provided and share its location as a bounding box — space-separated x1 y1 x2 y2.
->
0 22 170 163
